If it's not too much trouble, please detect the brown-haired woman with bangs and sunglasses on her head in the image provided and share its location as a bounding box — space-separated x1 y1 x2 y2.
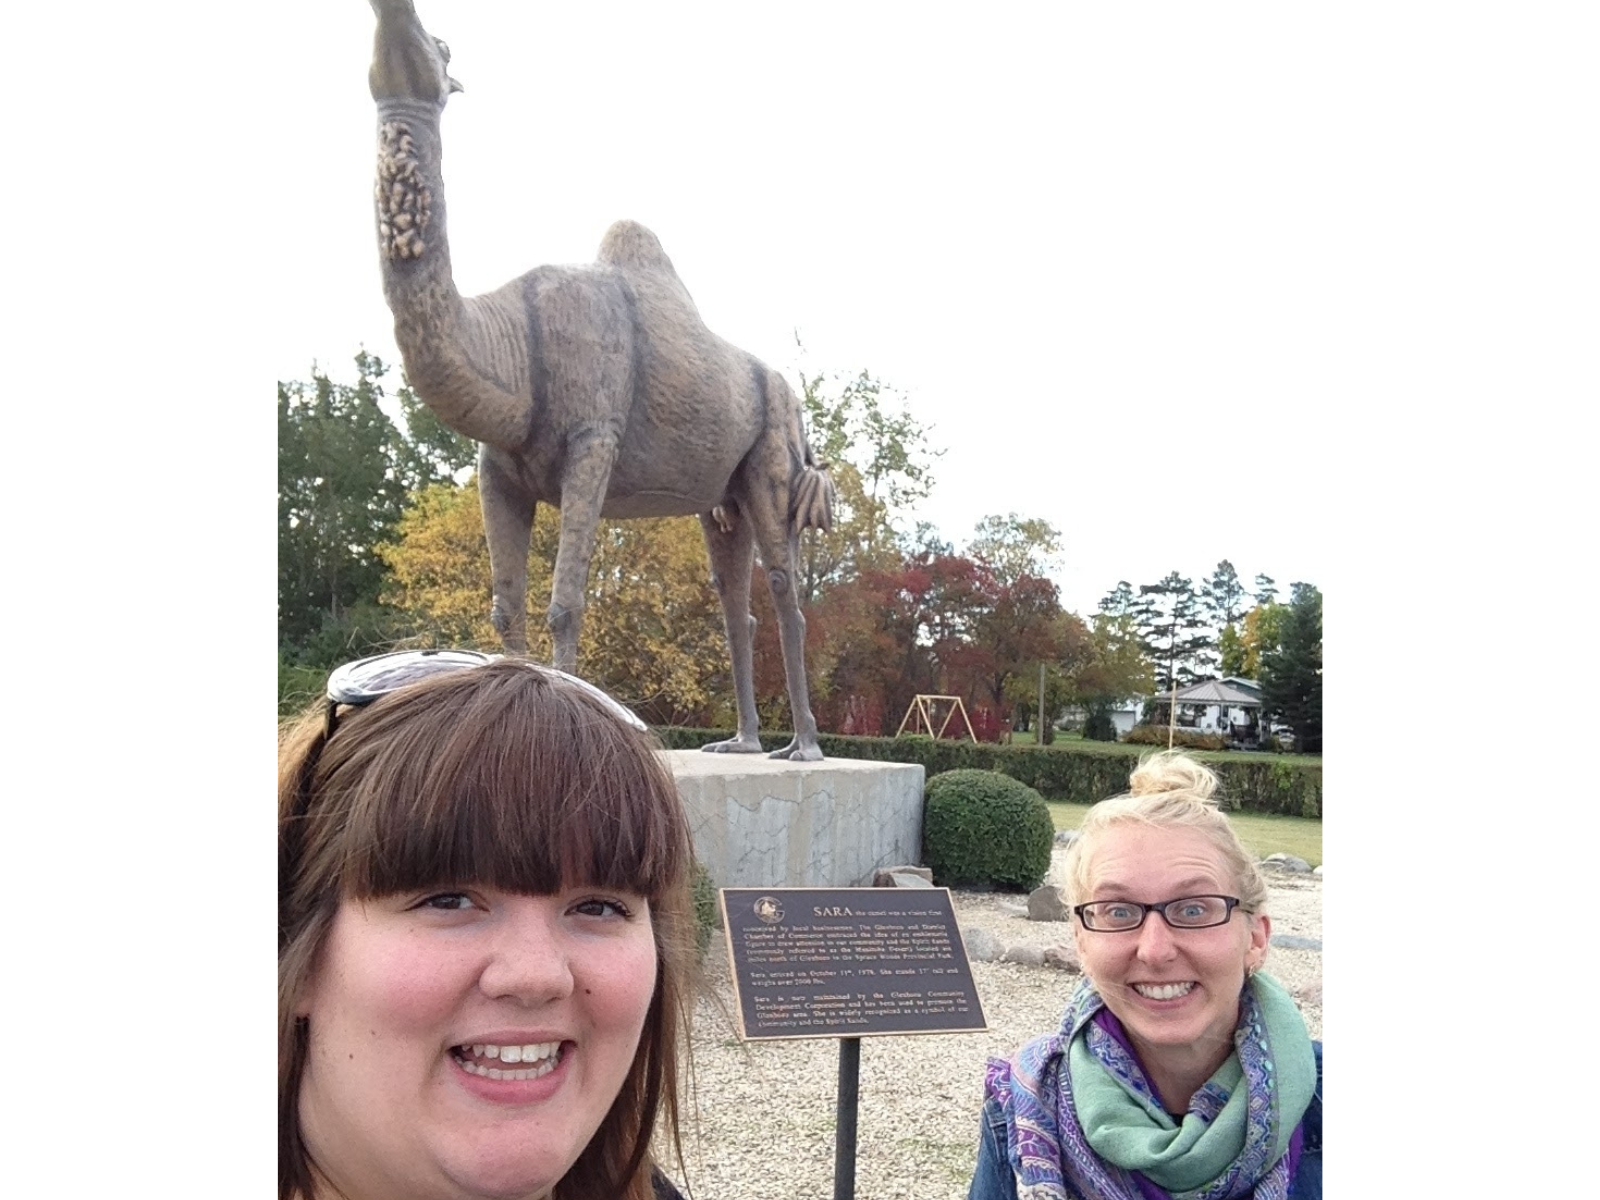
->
278 651 694 1200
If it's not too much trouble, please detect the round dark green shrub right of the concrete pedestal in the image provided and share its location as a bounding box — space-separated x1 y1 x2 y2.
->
922 770 1056 891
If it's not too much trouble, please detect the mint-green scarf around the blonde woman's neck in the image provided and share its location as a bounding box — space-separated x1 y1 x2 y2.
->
1067 973 1317 1200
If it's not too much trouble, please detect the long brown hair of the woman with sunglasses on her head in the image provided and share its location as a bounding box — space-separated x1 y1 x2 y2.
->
278 659 696 1200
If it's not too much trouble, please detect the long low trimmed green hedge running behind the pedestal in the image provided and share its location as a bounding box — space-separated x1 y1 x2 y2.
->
656 726 1322 818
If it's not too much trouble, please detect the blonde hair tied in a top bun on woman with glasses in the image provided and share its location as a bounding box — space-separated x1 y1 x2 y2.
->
1061 750 1267 912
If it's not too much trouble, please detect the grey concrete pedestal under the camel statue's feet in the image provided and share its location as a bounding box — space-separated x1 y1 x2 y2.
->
664 750 923 888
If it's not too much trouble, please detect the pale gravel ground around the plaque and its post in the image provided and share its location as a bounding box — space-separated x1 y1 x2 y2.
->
670 857 1322 1200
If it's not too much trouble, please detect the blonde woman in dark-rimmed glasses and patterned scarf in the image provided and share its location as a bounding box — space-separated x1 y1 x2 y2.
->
968 752 1322 1200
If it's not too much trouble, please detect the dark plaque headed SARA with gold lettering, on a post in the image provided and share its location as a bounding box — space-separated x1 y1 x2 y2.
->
720 888 987 1042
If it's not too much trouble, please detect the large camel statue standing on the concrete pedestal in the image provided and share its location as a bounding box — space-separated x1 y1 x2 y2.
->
368 0 834 762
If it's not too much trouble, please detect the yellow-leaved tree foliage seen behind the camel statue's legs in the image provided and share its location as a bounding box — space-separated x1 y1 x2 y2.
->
379 480 731 723
